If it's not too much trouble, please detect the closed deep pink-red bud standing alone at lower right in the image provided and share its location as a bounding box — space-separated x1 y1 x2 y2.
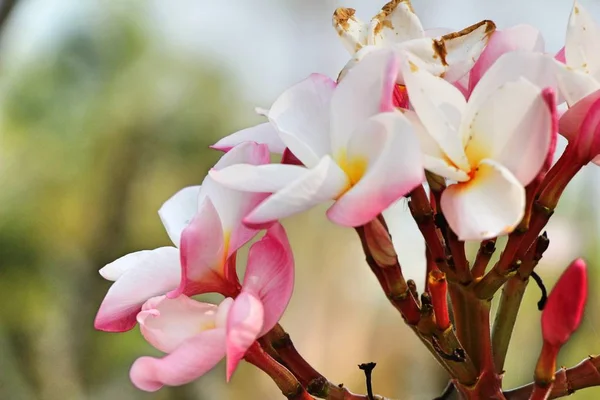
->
542 258 587 347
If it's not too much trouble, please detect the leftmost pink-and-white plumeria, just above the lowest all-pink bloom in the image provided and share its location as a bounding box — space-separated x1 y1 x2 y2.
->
94 142 269 332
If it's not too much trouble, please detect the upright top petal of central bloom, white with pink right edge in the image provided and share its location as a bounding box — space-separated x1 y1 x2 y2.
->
331 49 399 156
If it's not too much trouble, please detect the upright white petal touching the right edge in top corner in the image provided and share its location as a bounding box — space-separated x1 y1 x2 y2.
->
565 1 600 79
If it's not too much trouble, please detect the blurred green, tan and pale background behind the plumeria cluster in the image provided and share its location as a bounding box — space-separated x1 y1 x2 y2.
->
0 0 600 400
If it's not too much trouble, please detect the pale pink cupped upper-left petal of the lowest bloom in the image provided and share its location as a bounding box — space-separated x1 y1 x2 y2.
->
137 295 218 353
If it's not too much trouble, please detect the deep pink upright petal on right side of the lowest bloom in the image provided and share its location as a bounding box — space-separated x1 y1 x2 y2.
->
242 224 294 337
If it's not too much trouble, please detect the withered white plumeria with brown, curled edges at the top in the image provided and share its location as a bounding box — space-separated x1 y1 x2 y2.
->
333 0 496 83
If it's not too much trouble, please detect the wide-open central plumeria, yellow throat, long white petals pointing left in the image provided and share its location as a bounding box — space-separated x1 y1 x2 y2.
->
210 50 423 226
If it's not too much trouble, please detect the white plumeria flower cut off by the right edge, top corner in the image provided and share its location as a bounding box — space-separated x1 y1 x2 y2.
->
559 1 600 106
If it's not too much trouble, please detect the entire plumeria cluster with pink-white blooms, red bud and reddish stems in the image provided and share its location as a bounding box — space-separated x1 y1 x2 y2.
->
95 0 600 399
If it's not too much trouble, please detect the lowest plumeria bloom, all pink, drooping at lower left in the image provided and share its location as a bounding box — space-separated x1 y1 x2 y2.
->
130 224 294 391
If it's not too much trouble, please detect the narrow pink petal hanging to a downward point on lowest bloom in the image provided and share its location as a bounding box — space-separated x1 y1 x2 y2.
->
227 292 264 382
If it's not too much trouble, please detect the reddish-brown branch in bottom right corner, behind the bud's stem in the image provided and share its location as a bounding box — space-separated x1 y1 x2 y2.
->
504 356 600 400
